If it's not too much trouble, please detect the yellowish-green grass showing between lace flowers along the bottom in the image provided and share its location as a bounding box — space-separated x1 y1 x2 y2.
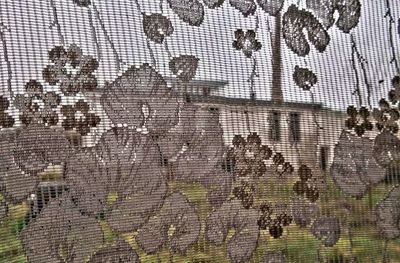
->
0 178 400 263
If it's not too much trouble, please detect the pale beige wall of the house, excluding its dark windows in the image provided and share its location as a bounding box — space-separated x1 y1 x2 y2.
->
197 102 345 169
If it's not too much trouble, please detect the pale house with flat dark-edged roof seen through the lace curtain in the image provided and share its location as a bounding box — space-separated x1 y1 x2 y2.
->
172 80 346 171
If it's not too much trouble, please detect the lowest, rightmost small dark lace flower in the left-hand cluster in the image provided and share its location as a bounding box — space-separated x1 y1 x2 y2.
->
61 100 100 136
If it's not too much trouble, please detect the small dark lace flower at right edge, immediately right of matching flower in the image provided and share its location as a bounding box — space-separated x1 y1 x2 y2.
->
372 99 400 134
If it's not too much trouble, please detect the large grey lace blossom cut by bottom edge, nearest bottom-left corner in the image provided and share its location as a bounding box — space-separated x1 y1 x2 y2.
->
21 195 103 263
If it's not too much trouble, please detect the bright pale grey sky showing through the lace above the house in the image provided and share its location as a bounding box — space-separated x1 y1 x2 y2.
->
0 0 400 109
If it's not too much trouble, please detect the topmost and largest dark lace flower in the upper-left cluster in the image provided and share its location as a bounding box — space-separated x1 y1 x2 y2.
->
43 44 99 96
